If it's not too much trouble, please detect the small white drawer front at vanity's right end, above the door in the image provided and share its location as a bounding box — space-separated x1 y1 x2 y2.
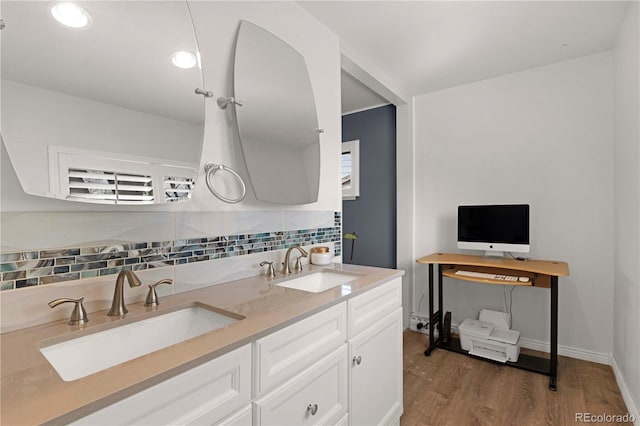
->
348 278 402 337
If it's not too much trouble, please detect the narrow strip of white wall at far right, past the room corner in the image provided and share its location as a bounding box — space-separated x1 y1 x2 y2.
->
613 2 640 418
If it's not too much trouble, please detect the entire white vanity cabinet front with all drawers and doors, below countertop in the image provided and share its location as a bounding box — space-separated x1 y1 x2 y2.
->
70 278 402 426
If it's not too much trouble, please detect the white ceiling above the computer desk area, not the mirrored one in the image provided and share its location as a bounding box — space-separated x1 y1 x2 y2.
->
300 1 629 109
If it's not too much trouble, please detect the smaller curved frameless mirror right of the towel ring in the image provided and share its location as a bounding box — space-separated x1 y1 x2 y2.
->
234 21 320 204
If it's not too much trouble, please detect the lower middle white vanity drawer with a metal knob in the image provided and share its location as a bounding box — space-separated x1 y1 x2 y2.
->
254 344 348 426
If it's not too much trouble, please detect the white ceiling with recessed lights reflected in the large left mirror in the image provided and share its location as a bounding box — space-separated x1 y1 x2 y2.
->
1 0 204 125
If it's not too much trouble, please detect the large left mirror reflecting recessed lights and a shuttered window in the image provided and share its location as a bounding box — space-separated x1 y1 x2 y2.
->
1 1 204 204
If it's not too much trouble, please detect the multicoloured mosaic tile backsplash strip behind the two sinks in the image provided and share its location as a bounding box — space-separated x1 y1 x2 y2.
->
0 212 342 290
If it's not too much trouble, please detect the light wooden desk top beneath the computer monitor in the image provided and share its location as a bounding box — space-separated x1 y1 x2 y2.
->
416 253 569 277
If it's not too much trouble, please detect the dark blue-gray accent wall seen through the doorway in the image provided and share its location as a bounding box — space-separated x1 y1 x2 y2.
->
342 105 396 268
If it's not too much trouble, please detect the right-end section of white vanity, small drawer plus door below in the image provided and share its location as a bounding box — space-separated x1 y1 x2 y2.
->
348 278 403 426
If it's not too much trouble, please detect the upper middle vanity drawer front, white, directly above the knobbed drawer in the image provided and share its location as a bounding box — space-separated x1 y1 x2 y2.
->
254 302 347 396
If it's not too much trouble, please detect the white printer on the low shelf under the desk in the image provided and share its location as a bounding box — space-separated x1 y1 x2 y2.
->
458 309 520 362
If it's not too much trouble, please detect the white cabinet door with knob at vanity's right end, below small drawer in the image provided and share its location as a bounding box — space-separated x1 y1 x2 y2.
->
349 308 402 426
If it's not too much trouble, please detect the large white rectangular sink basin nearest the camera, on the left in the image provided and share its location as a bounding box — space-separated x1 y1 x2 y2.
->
40 303 244 382
